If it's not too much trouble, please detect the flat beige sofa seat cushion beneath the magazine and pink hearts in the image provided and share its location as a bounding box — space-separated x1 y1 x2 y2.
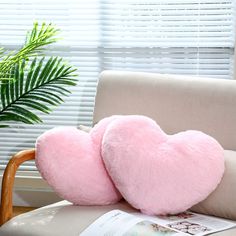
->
0 201 236 236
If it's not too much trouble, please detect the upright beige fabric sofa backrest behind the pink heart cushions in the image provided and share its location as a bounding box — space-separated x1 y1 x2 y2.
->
94 71 236 150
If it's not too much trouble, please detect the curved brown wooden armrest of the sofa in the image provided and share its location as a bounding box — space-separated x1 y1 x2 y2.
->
0 149 35 226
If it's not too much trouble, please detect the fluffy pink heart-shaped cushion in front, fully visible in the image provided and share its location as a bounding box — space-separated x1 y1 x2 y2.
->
102 116 224 215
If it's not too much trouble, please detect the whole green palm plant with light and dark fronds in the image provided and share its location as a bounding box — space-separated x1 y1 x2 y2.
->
0 23 76 128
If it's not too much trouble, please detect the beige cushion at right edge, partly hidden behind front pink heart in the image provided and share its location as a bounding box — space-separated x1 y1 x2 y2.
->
192 150 236 220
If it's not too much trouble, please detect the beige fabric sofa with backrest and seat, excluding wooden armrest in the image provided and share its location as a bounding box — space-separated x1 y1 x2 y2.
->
0 71 236 236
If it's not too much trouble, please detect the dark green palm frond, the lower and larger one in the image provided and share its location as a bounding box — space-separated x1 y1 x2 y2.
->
0 57 77 126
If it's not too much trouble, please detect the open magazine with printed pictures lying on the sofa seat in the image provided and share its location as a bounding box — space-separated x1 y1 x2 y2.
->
80 210 236 236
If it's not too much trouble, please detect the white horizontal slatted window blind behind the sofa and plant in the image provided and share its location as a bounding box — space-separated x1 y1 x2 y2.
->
0 0 235 170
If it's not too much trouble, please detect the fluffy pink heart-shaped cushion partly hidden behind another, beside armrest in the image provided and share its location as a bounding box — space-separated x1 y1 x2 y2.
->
36 116 121 205
